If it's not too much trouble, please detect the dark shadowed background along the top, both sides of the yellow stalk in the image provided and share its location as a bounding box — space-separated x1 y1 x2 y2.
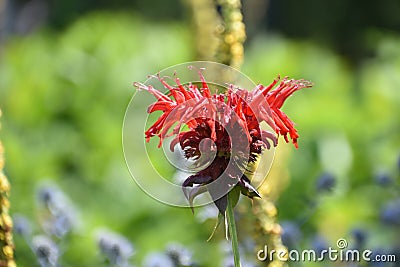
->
5 0 400 66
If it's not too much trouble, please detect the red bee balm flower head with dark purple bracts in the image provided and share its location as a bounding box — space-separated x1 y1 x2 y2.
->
134 71 312 214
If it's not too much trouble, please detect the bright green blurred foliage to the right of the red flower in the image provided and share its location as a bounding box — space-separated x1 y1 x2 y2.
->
243 31 400 264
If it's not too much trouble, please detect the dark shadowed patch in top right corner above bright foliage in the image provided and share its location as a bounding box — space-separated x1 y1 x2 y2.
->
267 0 400 65
